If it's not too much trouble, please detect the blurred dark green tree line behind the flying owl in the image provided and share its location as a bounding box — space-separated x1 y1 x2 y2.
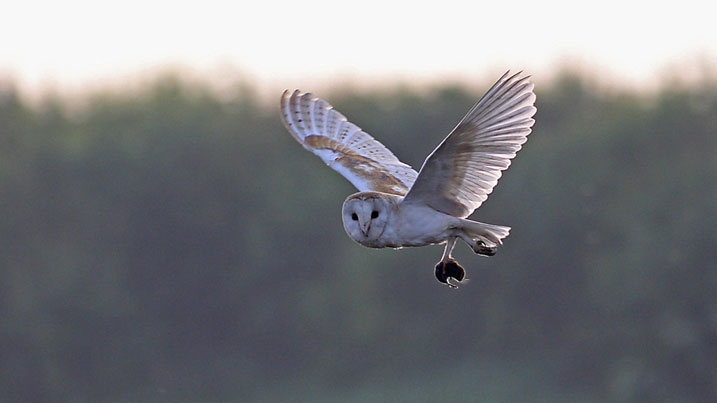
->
0 73 717 401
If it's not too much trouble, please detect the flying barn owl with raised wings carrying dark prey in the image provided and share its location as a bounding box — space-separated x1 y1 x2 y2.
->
281 72 536 288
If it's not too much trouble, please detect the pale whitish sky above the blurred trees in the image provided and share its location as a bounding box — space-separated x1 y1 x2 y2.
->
0 0 717 98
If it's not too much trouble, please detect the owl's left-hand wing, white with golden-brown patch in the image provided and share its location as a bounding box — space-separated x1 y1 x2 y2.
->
281 90 418 196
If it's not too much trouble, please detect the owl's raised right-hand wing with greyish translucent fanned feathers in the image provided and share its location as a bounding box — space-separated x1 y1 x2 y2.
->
404 72 536 217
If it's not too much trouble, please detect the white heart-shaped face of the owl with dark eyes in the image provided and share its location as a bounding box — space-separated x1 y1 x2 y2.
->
341 192 392 247
